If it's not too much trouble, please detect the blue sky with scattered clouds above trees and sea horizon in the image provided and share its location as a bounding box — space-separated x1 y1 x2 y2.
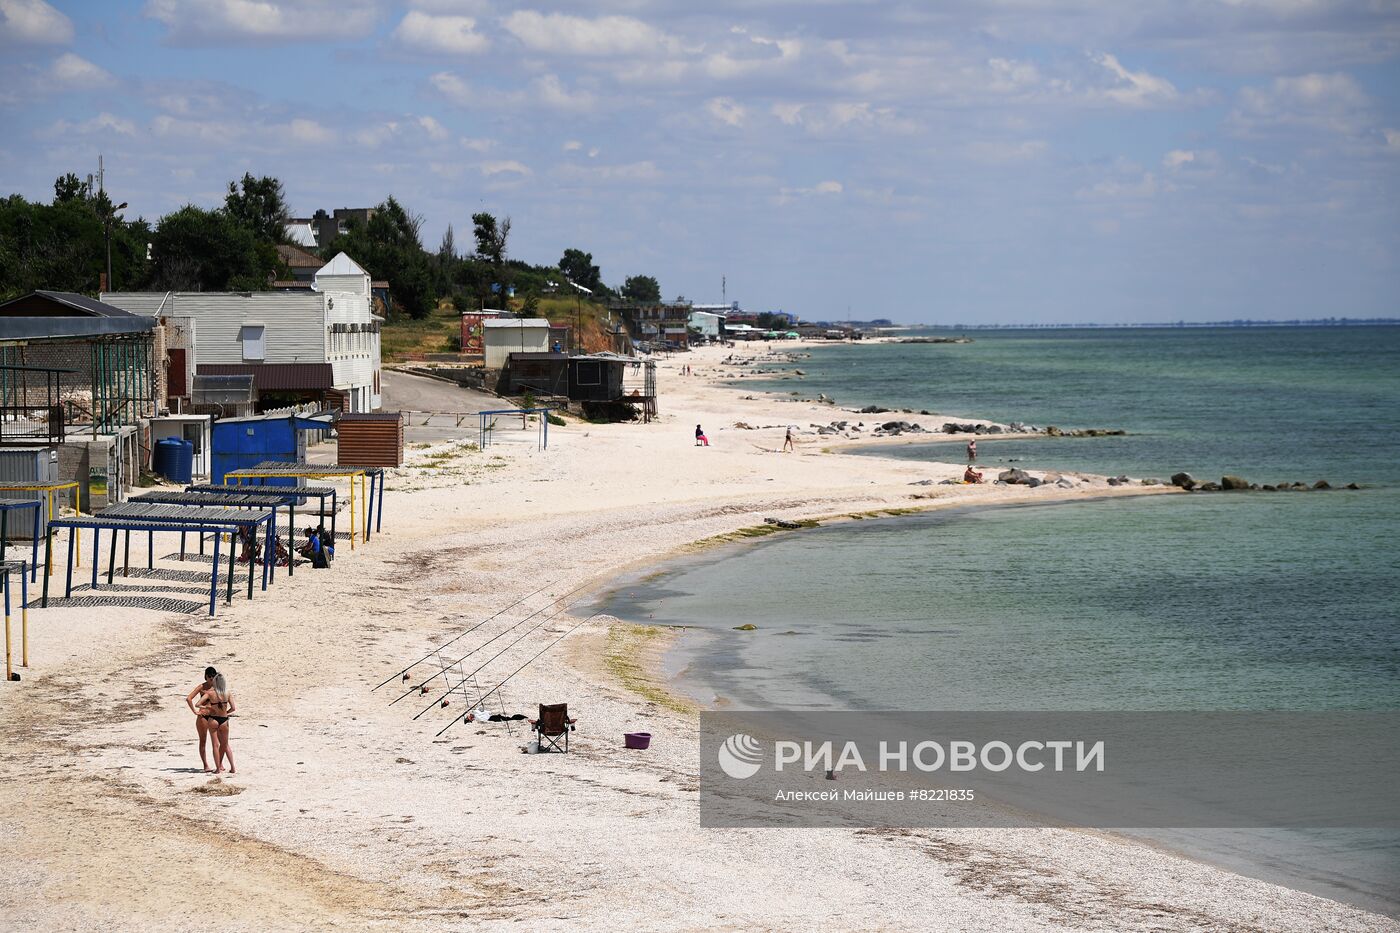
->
0 0 1400 324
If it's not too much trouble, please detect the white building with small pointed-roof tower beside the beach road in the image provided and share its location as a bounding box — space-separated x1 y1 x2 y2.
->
102 252 383 412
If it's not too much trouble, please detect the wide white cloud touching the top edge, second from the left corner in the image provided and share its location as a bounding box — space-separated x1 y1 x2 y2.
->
144 0 379 45
